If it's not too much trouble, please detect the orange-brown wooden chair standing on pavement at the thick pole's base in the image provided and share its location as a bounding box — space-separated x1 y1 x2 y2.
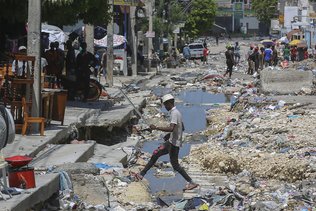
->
22 97 45 136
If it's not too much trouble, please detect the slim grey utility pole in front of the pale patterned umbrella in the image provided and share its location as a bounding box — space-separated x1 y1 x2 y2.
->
106 0 114 87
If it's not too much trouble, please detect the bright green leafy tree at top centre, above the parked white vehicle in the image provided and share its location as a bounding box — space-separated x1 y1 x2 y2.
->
185 0 216 37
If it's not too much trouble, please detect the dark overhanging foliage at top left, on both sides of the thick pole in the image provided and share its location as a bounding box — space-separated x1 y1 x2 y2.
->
0 0 112 26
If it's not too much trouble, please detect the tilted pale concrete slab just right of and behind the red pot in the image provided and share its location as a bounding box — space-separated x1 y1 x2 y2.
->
31 141 95 169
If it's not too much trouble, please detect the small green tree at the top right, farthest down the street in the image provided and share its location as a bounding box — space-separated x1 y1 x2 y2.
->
252 0 278 25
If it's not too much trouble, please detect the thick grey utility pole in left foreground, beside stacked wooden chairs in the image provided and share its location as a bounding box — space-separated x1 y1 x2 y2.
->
27 0 41 117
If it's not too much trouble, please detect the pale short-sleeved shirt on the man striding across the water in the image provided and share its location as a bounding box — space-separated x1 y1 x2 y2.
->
169 107 183 147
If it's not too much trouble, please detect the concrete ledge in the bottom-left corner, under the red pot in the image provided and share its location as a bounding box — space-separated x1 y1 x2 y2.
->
0 173 59 211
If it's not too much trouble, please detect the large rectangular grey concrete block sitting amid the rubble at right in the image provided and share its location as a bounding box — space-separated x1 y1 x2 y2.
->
260 69 313 94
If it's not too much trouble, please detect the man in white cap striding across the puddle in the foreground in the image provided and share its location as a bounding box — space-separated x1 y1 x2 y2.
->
135 94 199 190
